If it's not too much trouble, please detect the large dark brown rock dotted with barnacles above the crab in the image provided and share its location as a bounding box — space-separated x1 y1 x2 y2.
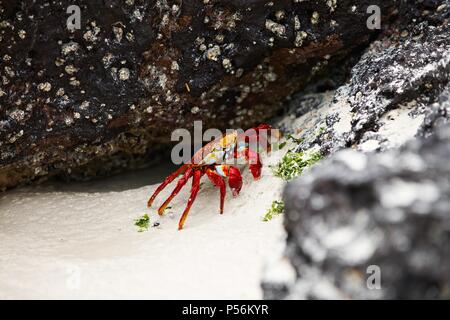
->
0 0 398 188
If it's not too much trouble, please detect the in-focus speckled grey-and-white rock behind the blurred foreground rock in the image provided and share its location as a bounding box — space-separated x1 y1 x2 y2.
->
276 1 450 154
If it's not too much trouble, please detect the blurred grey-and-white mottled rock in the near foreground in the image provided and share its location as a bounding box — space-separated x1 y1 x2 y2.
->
265 125 450 299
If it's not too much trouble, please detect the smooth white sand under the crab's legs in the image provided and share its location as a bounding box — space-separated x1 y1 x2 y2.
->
0 150 285 299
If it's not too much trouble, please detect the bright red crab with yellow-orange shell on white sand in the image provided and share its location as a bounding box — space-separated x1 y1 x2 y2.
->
148 124 279 230
